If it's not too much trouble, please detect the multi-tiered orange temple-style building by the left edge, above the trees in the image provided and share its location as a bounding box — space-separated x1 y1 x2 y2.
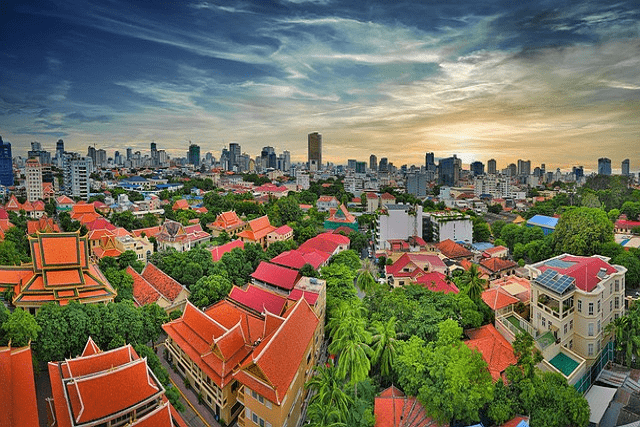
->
0 232 116 314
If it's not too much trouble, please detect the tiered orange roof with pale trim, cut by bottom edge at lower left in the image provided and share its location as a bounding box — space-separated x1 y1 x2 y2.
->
47 338 187 427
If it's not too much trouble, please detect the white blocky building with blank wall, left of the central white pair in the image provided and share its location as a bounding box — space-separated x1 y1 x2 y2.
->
376 206 422 250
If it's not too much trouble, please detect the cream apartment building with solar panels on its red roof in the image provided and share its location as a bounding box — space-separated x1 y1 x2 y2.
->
527 254 627 364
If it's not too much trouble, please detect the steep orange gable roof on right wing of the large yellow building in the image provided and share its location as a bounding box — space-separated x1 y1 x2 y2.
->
234 298 319 404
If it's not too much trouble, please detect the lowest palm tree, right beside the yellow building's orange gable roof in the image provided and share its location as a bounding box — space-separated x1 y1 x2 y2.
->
305 363 353 421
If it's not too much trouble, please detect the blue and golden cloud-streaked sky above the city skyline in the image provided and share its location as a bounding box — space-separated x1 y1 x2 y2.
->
0 0 640 171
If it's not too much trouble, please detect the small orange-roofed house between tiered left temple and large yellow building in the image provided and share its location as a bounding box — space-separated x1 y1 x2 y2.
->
126 263 191 313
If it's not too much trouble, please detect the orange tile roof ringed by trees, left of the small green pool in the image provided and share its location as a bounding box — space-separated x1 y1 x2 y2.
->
464 324 517 381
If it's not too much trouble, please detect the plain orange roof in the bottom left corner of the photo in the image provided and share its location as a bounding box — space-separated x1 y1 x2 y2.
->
0 347 40 427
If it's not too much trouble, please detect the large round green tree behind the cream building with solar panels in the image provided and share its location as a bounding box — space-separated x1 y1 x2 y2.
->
553 208 613 256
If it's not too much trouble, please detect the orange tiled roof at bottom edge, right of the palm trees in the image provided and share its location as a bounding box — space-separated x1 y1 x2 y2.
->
373 386 449 427
